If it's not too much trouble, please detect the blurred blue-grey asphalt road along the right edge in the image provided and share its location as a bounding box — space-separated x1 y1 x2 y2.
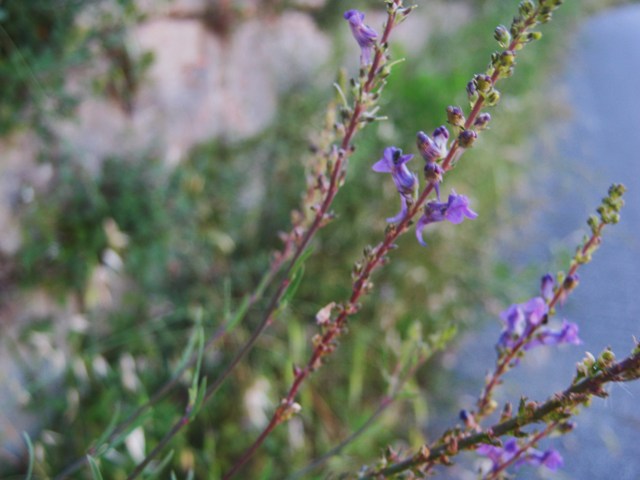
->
434 4 640 480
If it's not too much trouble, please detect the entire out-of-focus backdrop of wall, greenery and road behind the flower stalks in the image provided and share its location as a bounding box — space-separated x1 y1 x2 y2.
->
0 0 640 479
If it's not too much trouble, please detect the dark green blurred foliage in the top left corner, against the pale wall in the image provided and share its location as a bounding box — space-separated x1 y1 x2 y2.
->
0 0 153 135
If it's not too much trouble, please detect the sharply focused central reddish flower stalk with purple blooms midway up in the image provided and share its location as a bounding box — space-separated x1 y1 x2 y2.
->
224 0 560 479
